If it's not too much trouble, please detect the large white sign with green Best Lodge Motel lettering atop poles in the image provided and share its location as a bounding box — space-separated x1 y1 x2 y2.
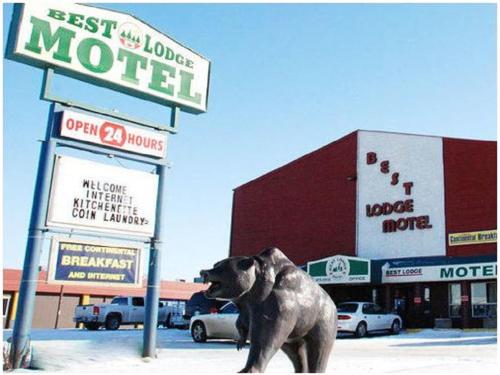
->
7 1 210 113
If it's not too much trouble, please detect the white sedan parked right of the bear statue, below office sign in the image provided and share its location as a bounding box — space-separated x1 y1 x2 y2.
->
337 302 403 337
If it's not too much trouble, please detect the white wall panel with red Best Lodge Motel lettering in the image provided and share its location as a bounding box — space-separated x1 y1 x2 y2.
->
356 131 446 259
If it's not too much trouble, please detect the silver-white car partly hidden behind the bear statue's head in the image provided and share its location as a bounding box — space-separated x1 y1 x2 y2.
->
189 302 240 342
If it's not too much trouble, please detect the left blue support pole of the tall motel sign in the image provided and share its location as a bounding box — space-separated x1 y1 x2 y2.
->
10 105 55 369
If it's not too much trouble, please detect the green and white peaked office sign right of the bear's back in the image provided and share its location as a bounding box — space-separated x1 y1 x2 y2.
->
307 255 370 284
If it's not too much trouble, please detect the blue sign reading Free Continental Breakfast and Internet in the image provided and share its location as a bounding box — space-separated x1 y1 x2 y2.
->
47 238 142 287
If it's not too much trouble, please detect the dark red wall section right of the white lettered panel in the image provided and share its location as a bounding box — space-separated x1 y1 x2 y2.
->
443 138 497 256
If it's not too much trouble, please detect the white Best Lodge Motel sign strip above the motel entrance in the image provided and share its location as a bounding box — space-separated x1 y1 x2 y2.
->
382 262 497 284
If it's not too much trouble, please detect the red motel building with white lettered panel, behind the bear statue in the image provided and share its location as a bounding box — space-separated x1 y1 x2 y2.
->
230 130 497 327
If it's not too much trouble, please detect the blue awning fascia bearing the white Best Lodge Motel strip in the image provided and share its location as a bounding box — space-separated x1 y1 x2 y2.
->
373 255 497 284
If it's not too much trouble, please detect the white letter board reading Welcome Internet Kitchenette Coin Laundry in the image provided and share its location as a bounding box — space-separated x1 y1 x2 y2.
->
47 155 158 237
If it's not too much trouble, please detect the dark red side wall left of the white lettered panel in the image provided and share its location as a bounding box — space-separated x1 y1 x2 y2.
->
230 132 357 264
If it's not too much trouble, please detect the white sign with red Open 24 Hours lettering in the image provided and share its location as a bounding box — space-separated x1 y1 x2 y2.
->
60 111 167 158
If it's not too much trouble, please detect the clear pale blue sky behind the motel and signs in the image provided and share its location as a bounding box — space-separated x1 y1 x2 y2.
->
3 4 496 280
